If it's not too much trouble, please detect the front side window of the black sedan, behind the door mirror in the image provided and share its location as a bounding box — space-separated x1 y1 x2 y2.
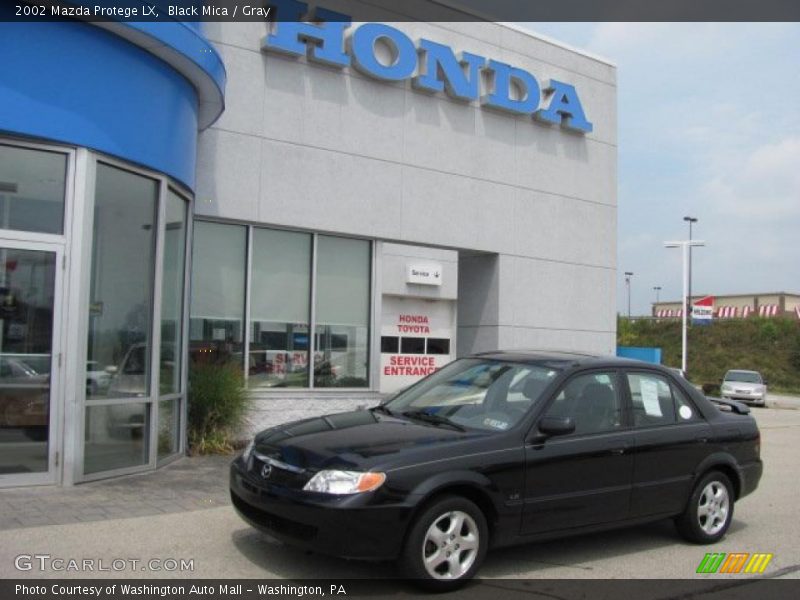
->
545 372 622 435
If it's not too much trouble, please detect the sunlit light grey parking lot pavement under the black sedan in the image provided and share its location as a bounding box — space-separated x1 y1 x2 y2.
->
0 408 800 579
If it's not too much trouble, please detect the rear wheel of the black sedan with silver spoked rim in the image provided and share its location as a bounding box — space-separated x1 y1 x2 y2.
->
675 471 735 544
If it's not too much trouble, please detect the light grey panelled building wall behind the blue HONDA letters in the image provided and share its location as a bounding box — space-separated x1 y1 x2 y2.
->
195 15 617 426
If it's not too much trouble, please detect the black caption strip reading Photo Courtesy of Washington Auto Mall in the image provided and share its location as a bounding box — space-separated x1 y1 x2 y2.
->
0 576 800 600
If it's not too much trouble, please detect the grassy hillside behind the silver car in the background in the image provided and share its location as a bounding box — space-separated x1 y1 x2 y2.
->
617 317 800 393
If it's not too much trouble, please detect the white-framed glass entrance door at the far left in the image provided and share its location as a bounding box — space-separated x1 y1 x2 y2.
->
0 241 61 486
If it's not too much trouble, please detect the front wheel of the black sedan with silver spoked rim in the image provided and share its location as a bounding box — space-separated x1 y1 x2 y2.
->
400 496 489 592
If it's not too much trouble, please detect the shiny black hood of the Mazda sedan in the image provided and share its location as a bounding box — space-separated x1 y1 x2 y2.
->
254 410 490 472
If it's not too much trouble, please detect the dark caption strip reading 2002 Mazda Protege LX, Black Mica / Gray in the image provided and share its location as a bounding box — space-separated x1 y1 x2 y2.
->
0 0 800 22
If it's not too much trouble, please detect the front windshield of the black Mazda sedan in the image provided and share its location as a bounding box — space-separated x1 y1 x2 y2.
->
385 358 558 431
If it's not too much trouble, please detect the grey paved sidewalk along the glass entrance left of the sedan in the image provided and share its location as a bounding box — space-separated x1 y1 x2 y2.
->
0 456 233 531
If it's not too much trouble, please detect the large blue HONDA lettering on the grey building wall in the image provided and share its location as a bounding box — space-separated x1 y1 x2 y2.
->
262 0 592 134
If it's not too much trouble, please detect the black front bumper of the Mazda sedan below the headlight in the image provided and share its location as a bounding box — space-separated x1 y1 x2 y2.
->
225 458 413 560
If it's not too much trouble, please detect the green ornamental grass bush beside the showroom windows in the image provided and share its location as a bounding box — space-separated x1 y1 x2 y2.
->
188 362 250 454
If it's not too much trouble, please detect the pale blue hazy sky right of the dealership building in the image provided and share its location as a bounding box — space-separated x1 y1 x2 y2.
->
524 23 800 315
